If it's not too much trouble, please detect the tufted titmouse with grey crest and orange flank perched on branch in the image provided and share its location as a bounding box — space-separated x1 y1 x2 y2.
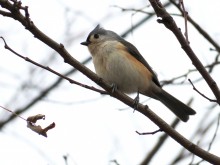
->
81 25 196 122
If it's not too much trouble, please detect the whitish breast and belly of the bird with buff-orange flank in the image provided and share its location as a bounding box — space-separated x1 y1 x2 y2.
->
90 41 152 93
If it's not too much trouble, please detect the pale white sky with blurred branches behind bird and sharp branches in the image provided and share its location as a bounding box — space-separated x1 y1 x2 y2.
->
0 0 220 165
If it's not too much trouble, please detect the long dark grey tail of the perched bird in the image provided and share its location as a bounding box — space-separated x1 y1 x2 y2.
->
156 89 196 122
